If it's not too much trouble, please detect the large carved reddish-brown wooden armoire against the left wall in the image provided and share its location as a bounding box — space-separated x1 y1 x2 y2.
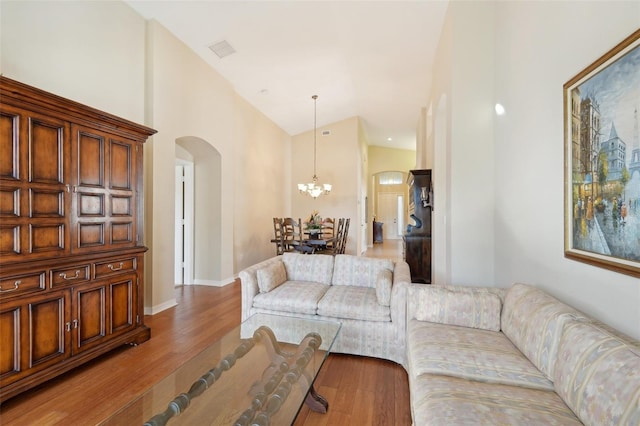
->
0 76 155 402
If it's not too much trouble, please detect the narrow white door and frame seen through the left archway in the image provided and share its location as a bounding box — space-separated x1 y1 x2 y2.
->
174 159 194 285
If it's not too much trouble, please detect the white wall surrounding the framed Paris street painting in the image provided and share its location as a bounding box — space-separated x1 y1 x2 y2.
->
495 1 640 338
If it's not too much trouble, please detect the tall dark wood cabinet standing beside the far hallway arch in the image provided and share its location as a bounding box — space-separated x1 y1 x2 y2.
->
403 170 433 284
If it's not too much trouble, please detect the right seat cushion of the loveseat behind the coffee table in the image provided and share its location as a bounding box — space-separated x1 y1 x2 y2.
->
318 286 391 327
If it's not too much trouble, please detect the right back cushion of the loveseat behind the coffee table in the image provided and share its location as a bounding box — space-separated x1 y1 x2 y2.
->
331 254 393 288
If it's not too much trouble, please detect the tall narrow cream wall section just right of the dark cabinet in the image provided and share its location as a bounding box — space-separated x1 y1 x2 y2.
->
426 2 495 285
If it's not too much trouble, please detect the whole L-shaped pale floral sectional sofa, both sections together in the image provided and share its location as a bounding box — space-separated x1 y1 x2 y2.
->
240 253 640 426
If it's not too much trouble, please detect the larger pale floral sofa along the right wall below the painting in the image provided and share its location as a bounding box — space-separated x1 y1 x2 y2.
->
406 284 640 426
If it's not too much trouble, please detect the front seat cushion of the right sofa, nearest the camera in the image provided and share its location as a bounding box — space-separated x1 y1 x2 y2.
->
411 374 582 426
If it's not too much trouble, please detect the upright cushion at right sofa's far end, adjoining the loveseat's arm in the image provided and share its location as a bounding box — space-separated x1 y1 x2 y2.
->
410 286 502 331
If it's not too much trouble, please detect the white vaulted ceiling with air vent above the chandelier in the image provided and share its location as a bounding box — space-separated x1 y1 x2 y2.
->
127 0 448 149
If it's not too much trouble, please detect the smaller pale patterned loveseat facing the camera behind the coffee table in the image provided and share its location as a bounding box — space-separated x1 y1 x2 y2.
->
239 253 411 365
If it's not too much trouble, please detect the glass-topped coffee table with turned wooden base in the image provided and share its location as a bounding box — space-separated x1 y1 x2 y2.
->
102 314 341 426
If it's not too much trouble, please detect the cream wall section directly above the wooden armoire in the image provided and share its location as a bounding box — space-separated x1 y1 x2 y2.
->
0 1 146 124
